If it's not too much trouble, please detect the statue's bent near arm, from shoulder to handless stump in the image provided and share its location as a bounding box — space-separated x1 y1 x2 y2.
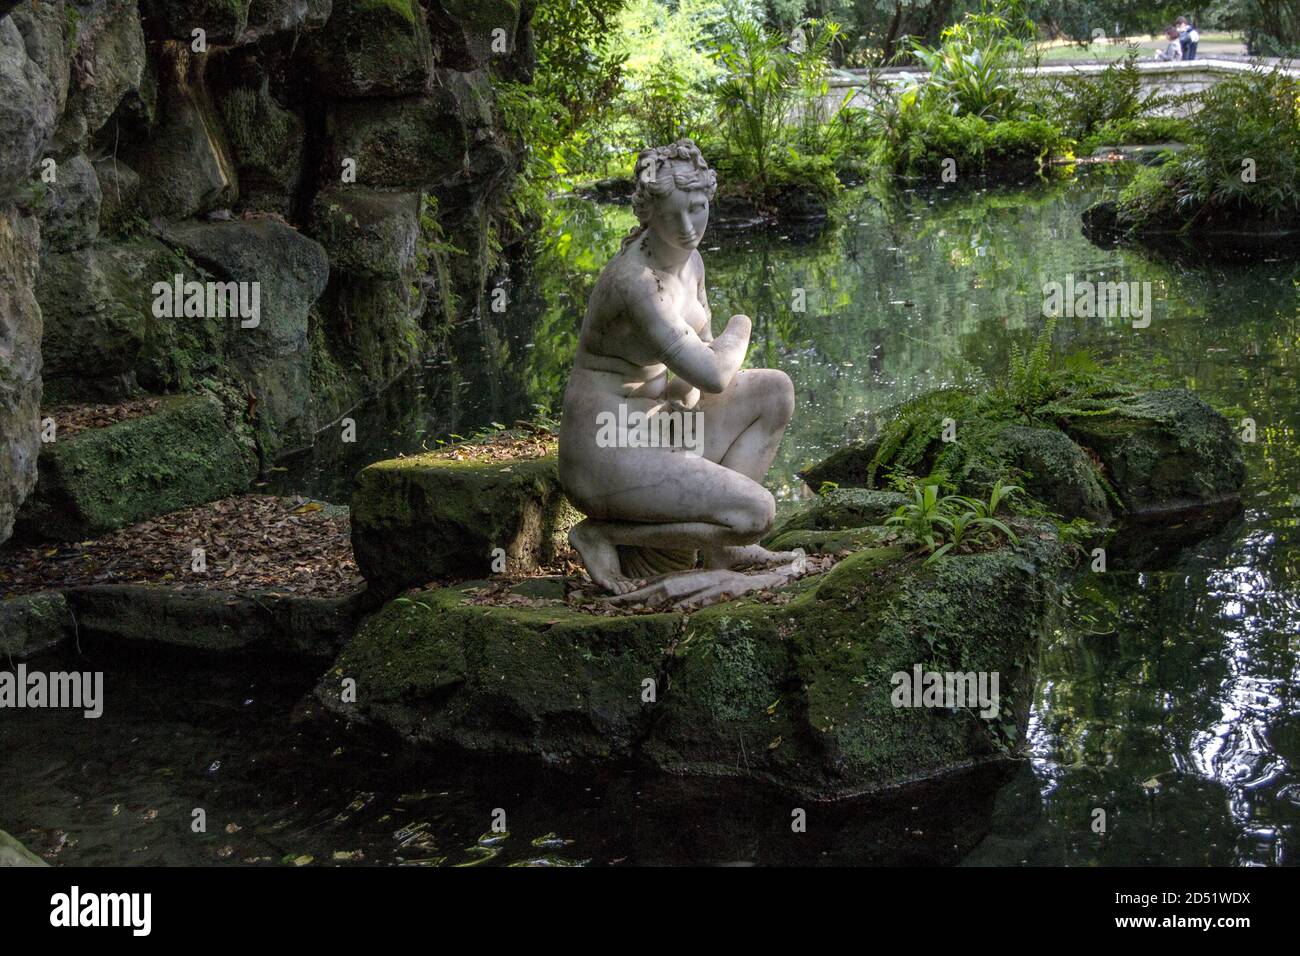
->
623 278 750 394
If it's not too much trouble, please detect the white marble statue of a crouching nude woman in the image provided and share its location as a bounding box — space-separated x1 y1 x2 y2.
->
559 139 807 604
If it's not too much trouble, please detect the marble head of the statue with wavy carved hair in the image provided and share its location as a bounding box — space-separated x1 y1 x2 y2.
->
632 139 718 250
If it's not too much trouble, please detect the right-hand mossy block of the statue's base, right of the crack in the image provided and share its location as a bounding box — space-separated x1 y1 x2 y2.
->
645 532 1063 797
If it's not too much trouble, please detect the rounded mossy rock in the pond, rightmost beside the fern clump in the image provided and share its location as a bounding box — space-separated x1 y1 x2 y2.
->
1065 389 1245 516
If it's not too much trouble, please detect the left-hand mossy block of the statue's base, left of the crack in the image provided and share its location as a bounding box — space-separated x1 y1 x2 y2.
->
316 589 680 761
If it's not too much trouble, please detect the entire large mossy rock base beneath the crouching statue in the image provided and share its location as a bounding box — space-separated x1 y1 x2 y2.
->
316 511 1066 799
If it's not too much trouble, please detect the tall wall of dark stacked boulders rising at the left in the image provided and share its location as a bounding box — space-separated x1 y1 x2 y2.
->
0 0 532 541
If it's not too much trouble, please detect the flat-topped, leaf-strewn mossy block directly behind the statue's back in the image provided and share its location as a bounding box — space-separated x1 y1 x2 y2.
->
352 451 580 594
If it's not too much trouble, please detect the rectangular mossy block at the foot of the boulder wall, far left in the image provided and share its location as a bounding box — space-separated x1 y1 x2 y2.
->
18 393 257 541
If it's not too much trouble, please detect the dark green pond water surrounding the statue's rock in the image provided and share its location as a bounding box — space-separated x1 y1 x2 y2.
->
0 170 1300 865
